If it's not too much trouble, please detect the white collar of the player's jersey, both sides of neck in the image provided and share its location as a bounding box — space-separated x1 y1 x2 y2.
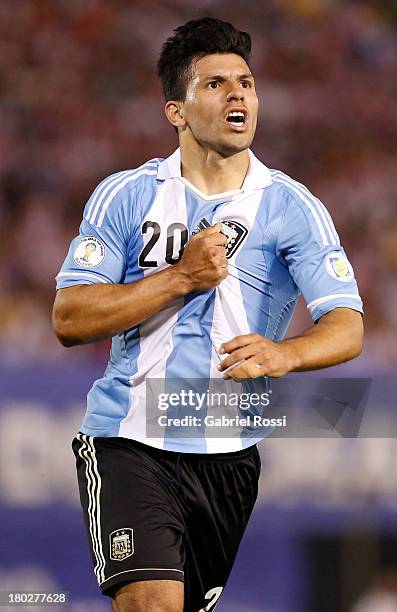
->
157 148 272 191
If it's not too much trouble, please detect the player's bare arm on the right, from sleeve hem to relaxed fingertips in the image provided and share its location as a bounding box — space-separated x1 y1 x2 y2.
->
219 308 363 380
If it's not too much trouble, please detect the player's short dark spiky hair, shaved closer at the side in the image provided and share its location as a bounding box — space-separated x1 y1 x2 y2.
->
157 17 251 102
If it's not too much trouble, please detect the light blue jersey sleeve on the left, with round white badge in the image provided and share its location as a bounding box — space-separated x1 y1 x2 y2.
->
56 172 131 289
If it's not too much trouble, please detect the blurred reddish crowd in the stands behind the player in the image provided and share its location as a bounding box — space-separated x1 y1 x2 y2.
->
0 0 397 370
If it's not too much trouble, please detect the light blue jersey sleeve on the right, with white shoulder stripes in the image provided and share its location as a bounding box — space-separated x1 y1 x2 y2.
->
277 190 363 321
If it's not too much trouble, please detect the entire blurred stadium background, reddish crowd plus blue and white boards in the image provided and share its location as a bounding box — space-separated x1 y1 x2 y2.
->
0 0 397 612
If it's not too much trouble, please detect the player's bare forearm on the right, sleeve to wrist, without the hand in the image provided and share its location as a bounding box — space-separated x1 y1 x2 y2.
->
282 308 363 372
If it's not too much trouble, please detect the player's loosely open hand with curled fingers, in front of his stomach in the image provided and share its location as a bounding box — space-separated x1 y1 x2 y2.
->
219 334 296 380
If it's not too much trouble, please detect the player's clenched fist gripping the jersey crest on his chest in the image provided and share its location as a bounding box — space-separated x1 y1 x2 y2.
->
174 223 228 291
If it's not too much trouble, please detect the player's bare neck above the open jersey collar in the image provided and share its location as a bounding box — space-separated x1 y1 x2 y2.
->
181 140 249 196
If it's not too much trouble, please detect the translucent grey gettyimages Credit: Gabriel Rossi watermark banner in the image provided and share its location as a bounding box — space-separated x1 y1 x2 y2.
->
145 376 371 439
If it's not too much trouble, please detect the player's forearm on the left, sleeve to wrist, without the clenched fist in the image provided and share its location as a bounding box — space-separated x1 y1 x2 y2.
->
52 266 190 346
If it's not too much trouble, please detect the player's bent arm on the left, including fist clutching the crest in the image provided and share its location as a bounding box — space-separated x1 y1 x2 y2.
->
52 224 228 346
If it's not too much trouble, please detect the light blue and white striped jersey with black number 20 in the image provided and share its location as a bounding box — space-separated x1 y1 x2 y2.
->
57 149 362 453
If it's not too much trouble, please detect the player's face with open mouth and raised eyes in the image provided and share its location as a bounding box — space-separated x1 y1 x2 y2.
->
176 53 258 156
